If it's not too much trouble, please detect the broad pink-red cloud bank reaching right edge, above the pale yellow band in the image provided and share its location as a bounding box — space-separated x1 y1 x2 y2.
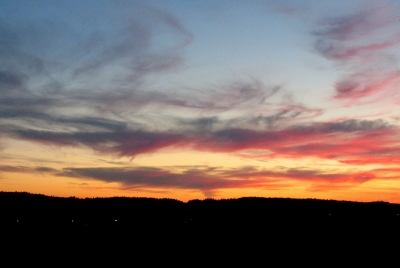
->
195 120 400 163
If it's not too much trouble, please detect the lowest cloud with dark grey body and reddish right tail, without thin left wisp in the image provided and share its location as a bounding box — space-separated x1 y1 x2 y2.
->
58 166 375 195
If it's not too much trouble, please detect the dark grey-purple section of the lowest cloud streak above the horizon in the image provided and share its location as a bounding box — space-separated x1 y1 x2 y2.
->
59 166 282 195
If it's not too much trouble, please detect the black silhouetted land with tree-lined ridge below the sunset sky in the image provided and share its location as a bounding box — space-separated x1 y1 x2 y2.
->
0 192 400 263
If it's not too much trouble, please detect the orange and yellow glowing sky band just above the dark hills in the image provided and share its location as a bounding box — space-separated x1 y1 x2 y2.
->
0 147 400 203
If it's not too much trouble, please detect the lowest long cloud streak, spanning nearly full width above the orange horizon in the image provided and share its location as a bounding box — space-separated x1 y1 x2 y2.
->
0 159 399 196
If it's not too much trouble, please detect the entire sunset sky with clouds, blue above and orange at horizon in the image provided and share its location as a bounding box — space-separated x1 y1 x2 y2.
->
0 0 400 203
